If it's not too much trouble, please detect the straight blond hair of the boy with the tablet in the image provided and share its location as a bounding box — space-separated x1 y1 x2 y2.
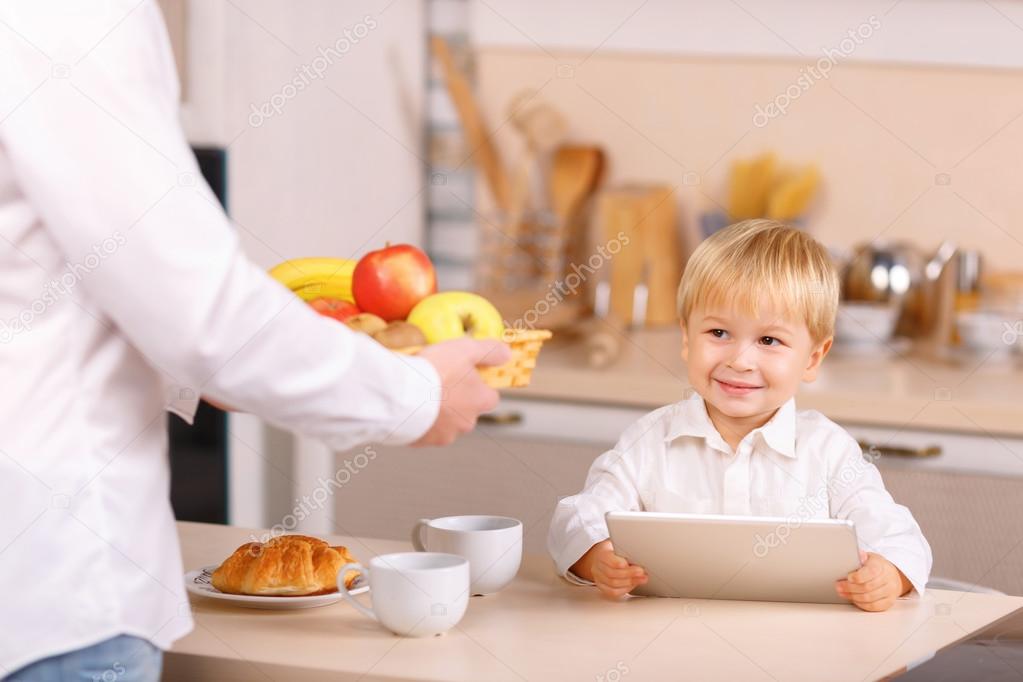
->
677 220 839 344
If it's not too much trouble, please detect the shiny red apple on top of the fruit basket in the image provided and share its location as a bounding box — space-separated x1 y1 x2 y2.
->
352 244 437 322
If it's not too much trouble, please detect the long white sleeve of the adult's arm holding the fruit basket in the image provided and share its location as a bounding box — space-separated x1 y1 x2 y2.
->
0 1 440 450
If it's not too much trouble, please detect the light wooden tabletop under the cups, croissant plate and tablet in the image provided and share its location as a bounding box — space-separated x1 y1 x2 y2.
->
164 522 1023 682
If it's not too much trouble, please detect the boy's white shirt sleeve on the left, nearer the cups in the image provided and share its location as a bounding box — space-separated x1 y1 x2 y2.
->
547 429 641 585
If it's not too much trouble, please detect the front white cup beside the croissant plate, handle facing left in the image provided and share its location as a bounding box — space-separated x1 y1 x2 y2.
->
338 552 469 637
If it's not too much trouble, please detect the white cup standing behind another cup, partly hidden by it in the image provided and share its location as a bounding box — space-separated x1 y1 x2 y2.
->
412 515 522 595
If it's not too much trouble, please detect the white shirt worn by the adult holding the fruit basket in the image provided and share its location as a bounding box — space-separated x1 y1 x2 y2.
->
0 0 439 678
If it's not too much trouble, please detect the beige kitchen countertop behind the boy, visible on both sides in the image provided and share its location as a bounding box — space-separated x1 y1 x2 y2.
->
515 328 1023 436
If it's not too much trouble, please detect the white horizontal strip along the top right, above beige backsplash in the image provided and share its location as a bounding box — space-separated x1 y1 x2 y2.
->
470 0 1023 67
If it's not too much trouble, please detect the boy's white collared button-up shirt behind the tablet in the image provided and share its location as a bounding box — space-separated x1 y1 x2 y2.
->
547 395 931 594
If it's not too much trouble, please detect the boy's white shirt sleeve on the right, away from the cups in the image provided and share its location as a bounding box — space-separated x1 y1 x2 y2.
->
829 431 932 595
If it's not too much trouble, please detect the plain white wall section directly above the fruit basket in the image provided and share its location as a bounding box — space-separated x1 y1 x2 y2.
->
173 0 425 266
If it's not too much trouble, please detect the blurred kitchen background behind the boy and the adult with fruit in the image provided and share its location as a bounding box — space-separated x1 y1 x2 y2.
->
161 0 1023 594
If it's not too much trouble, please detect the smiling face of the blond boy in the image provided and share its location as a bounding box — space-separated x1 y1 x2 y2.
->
681 307 832 419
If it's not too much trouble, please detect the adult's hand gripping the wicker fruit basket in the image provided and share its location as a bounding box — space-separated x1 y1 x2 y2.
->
413 338 512 445
